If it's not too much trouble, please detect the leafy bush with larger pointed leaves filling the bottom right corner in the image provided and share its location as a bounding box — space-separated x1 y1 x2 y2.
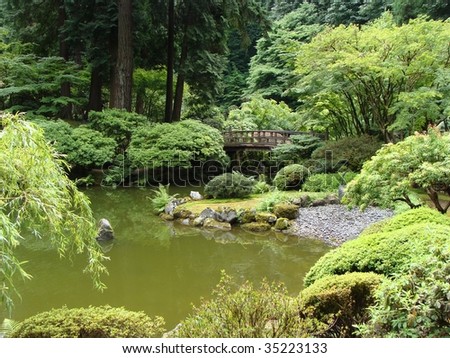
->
358 243 450 338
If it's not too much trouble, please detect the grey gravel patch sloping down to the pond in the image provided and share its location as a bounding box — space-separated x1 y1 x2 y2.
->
291 205 393 246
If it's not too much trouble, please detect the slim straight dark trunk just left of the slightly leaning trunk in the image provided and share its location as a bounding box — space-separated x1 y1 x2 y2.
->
165 0 175 122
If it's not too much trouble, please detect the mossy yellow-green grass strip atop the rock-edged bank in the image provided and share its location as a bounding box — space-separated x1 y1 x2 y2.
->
178 191 330 215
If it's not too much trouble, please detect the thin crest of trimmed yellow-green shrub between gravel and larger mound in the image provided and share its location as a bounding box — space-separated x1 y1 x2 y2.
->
361 207 450 235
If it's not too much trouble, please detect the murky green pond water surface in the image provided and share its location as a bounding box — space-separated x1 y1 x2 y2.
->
7 188 329 328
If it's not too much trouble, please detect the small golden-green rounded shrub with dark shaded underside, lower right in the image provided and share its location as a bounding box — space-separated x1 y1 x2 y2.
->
300 272 383 338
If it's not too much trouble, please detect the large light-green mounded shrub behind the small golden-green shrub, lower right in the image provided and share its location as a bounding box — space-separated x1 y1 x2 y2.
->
304 223 450 286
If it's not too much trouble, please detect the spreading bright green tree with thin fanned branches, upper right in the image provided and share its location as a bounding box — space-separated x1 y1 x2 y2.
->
295 13 450 142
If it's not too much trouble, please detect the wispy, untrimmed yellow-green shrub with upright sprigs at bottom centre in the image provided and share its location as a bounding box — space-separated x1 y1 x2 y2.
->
175 274 299 338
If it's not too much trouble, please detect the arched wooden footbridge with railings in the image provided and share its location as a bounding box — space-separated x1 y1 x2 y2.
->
223 130 304 152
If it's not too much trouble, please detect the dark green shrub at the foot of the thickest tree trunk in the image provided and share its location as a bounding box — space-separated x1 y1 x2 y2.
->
89 109 148 150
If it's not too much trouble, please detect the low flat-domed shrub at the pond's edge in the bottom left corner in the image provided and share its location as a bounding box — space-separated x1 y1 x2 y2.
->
8 306 164 338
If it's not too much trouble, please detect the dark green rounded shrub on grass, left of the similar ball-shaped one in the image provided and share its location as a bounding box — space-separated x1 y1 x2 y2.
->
205 172 254 198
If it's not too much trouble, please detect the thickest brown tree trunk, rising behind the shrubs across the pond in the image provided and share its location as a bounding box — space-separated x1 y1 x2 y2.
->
109 0 133 111
